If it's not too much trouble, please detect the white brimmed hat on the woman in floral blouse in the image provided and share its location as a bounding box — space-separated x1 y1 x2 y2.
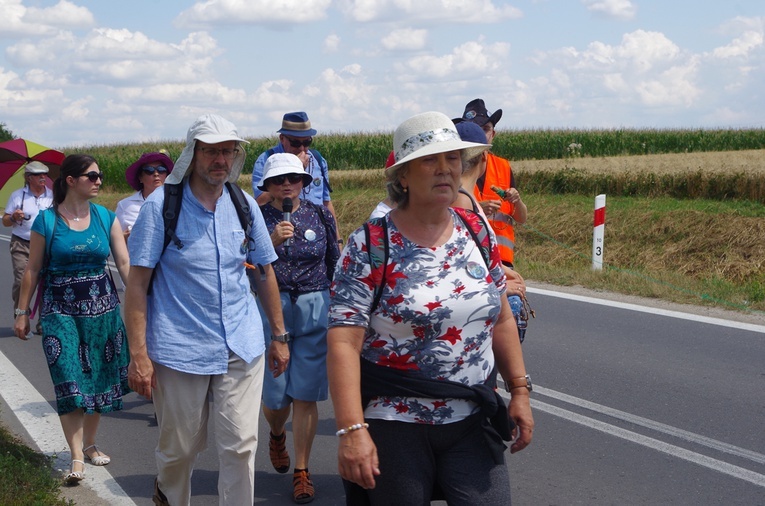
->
385 112 491 175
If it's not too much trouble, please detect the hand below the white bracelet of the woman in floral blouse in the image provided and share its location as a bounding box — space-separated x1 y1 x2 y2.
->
337 429 380 489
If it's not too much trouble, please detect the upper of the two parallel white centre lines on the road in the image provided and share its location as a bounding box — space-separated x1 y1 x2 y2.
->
534 385 765 464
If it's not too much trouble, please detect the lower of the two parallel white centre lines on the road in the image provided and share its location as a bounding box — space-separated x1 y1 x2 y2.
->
531 399 765 487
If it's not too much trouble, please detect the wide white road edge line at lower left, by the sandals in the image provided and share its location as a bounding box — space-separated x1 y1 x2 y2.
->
0 352 135 506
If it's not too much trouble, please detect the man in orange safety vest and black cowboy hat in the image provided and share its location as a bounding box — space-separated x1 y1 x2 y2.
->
452 98 527 268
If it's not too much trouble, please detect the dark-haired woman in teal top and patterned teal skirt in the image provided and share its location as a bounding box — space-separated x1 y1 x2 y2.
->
14 155 130 484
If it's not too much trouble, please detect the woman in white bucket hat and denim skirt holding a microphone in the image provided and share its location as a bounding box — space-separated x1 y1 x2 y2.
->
258 153 340 504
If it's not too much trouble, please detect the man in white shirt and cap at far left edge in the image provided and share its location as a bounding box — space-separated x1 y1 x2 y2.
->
3 161 53 334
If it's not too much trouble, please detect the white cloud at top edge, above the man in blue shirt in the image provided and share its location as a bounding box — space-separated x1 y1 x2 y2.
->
179 0 332 29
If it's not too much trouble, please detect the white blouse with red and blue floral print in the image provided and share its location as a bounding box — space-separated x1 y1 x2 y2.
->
329 209 505 424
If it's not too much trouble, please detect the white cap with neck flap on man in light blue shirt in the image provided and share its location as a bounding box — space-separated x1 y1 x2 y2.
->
165 114 249 184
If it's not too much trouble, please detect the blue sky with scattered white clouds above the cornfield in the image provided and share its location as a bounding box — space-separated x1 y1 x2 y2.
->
0 0 765 148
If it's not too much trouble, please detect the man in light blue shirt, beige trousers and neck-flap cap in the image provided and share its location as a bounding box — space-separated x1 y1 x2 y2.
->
125 114 289 506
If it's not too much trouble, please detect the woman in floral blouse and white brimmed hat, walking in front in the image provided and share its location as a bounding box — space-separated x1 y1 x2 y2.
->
327 112 534 505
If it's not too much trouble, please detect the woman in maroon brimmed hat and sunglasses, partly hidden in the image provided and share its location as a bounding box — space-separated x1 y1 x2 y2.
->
116 153 173 241
